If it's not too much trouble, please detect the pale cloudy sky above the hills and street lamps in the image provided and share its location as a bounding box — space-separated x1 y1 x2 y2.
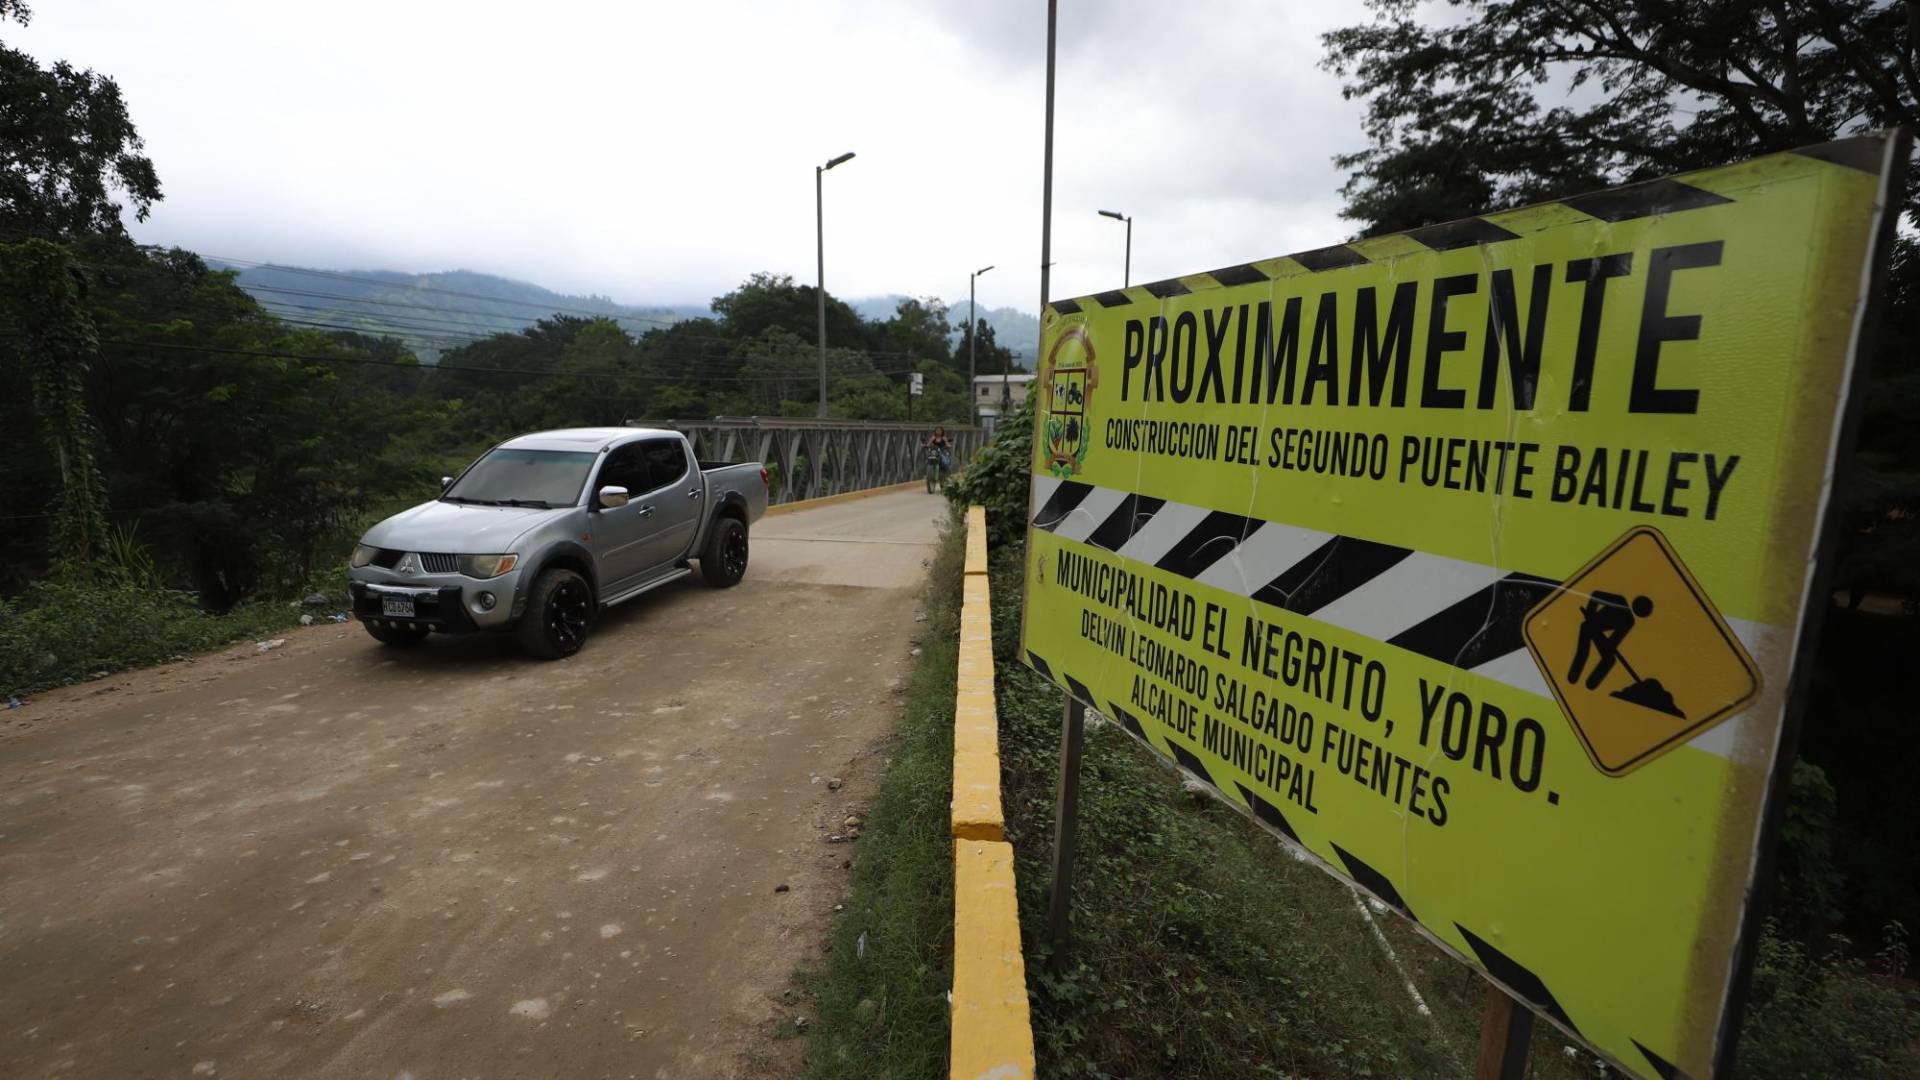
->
0 0 1363 309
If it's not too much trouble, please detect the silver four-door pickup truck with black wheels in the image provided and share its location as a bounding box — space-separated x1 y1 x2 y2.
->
348 427 766 659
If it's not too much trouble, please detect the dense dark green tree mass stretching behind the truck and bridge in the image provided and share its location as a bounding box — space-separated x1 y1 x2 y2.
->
0 0 1012 694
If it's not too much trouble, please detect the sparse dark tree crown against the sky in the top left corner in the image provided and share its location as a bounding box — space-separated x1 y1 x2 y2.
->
0 0 161 240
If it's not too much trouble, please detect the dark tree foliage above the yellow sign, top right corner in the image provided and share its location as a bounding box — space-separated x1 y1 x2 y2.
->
1325 0 1920 234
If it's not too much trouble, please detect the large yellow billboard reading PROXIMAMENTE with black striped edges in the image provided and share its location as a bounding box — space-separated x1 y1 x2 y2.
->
1021 133 1907 1080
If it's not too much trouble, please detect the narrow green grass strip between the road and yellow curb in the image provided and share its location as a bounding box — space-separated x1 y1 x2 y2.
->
801 507 964 1080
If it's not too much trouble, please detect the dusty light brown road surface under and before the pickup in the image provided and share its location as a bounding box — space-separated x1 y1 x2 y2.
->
0 492 945 1080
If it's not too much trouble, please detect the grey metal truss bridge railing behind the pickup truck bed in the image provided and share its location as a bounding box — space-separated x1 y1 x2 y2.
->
628 417 985 503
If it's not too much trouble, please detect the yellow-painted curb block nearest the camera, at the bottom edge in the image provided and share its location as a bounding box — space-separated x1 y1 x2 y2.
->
948 840 1033 1080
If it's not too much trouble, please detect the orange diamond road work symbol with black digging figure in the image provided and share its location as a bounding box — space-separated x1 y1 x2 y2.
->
1524 527 1761 776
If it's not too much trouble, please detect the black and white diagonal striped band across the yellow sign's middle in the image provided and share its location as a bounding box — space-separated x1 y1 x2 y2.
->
1029 477 1788 757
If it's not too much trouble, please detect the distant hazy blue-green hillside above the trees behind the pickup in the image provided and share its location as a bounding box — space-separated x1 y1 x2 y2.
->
215 263 708 357
